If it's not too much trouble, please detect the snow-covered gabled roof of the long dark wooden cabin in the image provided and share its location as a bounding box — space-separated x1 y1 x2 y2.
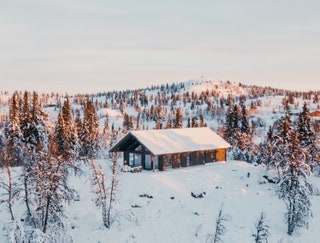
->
110 127 231 155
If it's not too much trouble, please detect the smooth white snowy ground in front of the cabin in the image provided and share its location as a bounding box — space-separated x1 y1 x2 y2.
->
68 161 320 242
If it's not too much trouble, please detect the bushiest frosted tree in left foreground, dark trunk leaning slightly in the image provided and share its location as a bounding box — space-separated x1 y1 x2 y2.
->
30 141 74 233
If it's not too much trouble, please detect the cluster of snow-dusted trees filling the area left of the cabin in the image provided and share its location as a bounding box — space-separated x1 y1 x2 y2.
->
0 92 117 242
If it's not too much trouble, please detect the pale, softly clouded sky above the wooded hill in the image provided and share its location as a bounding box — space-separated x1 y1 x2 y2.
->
0 0 320 94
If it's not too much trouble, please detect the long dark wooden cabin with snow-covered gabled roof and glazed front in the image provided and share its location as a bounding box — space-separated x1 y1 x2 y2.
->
109 127 231 171
